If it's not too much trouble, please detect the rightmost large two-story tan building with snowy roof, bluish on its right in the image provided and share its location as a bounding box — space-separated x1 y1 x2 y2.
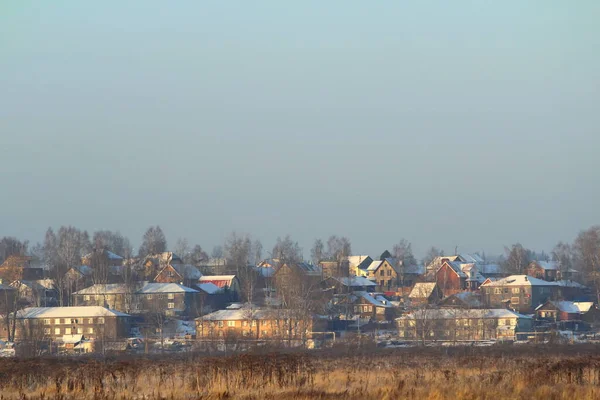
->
480 275 560 313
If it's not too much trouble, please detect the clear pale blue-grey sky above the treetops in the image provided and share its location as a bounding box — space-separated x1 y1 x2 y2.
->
0 0 600 256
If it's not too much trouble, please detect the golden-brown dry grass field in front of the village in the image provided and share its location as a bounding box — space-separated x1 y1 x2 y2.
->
0 346 600 400
